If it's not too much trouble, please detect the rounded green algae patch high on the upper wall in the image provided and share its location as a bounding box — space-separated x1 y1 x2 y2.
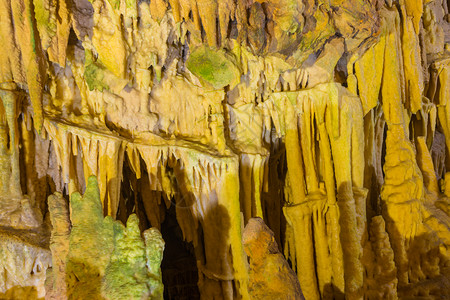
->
186 46 240 89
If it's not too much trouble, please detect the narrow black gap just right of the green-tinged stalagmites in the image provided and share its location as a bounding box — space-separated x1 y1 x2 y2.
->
161 200 200 300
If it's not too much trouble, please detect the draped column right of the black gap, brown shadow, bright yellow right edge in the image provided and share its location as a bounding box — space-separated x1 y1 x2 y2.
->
181 157 248 299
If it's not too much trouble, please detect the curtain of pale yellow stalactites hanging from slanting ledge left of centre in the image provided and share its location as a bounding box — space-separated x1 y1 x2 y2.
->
38 120 251 295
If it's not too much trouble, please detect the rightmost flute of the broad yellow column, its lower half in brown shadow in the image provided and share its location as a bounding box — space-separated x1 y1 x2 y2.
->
326 87 366 299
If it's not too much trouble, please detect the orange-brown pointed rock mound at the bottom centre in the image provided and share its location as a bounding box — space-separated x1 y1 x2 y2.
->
242 218 305 299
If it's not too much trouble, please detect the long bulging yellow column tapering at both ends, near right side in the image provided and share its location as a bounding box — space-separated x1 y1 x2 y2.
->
381 7 424 286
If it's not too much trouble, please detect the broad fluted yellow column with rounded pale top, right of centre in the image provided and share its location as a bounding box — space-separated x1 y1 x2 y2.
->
284 84 367 299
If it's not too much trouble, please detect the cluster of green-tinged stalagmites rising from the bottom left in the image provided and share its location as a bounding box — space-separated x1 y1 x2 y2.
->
45 176 164 299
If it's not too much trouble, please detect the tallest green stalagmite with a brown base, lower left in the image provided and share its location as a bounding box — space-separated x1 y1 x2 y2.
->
66 177 114 299
